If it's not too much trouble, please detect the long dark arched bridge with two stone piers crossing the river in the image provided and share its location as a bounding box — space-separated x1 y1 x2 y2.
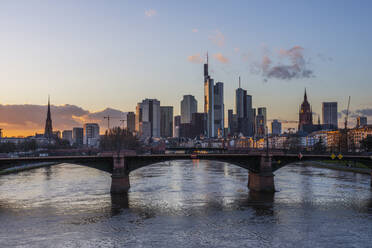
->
0 153 372 193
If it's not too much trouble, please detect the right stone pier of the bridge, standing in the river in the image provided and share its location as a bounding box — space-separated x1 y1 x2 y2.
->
248 156 275 193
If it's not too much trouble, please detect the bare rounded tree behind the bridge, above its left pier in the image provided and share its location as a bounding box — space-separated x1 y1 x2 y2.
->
100 127 140 153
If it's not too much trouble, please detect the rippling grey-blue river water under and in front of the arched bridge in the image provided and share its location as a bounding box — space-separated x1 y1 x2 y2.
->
0 161 372 248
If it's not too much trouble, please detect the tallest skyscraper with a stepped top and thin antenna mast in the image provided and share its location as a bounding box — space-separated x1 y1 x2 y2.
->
204 54 215 137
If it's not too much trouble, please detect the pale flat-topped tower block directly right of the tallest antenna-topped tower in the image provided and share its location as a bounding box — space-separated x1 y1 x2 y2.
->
213 82 225 136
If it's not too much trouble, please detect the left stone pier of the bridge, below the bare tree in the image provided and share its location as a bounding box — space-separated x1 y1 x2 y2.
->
110 156 130 194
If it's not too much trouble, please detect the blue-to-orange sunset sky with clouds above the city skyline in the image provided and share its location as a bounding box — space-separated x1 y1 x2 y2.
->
0 0 372 136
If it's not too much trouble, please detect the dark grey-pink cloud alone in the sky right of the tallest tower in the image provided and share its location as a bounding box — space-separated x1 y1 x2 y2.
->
251 46 314 81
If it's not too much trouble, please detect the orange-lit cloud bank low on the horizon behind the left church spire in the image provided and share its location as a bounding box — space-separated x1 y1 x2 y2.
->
0 104 125 135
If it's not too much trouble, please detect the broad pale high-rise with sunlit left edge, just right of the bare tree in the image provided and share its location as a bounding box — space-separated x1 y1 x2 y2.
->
136 99 160 138
